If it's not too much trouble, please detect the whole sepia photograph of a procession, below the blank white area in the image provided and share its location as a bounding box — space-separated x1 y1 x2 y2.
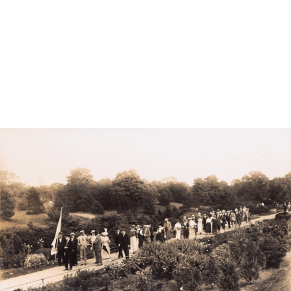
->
0 128 291 291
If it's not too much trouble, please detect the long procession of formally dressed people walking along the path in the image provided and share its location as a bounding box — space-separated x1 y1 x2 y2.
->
56 206 251 270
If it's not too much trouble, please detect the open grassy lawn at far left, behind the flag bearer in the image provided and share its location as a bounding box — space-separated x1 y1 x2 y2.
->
0 210 48 230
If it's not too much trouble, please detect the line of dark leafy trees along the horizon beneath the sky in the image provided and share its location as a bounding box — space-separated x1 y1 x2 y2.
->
0 168 291 218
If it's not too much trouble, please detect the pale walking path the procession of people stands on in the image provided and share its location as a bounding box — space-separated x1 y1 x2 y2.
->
0 214 275 291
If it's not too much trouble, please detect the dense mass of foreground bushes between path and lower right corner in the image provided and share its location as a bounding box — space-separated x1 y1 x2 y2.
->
16 220 290 291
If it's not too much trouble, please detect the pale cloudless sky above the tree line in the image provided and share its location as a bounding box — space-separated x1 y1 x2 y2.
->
0 128 291 186
